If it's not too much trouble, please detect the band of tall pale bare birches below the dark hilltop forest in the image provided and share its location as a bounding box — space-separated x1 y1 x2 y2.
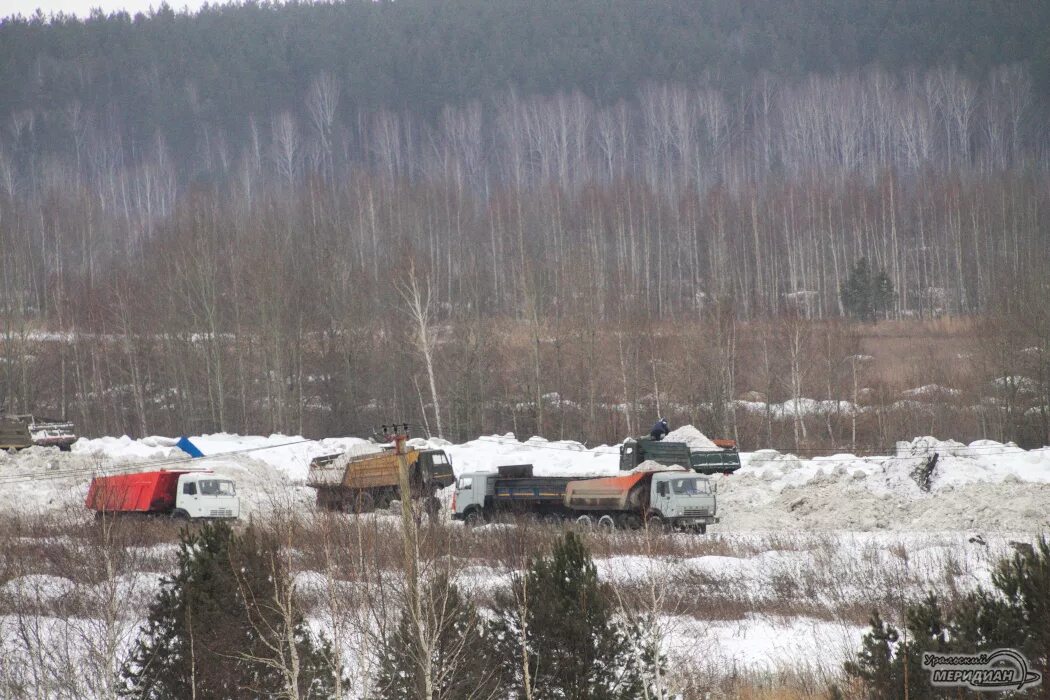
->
6 66 1050 318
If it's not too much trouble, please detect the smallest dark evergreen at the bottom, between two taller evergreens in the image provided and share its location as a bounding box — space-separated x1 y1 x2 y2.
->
378 576 497 700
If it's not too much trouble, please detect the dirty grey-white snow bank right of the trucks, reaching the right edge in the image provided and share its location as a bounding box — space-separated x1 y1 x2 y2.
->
719 437 1050 531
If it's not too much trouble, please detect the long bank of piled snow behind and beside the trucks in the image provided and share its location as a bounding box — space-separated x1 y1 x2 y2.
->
0 426 1050 532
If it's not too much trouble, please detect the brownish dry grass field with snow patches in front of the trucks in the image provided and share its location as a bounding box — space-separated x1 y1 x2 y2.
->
0 505 1006 699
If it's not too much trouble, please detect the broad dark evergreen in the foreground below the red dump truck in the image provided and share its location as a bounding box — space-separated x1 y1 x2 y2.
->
121 523 335 700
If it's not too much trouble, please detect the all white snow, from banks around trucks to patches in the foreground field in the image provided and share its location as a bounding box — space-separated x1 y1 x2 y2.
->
0 426 1050 696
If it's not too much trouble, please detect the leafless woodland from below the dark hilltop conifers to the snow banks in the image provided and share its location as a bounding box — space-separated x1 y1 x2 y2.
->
0 67 1050 442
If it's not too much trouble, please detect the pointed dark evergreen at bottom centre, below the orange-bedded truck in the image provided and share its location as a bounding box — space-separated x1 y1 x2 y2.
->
492 532 657 700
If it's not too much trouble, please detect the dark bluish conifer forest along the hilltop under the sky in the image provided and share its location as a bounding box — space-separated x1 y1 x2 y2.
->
0 0 1050 167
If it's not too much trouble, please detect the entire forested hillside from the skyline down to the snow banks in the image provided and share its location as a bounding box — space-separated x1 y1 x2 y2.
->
0 0 1050 448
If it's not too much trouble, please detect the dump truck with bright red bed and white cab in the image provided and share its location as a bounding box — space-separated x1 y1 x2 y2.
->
84 469 240 519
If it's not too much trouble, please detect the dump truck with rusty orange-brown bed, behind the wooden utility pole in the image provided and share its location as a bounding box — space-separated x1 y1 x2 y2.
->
307 446 456 513
